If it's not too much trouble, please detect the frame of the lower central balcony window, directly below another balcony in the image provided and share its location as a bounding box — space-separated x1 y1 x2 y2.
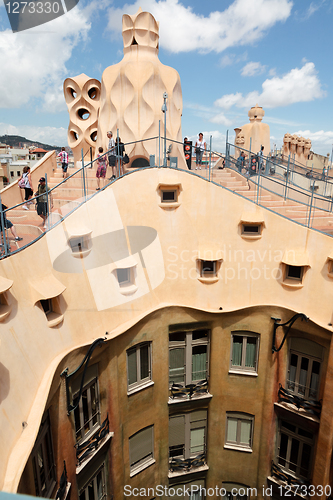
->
169 408 208 462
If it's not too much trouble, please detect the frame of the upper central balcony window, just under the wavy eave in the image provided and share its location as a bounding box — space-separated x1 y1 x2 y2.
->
169 327 211 388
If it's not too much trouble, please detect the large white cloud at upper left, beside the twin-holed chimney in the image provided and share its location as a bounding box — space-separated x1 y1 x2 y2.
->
0 7 90 112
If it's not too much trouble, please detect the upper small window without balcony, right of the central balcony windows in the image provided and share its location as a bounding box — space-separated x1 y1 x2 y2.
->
230 332 259 373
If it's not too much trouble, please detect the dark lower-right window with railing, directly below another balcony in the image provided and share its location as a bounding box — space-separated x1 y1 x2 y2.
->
277 420 314 479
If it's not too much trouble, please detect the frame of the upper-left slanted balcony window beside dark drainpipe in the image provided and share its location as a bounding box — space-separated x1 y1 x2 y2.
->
72 365 101 443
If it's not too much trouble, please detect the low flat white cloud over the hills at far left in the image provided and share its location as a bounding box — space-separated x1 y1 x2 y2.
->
0 123 67 146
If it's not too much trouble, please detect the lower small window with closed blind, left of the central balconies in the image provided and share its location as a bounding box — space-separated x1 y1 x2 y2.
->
129 425 155 476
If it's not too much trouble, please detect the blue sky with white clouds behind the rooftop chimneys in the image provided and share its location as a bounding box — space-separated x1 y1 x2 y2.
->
0 0 333 156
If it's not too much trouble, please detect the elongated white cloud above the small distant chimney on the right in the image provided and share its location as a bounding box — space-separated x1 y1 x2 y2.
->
215 62 326 109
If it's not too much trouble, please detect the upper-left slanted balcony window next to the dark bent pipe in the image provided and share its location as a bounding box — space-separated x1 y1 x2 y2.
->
72 365 100 442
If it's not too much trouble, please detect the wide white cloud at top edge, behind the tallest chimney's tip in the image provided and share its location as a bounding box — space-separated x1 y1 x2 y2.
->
108 0 293 53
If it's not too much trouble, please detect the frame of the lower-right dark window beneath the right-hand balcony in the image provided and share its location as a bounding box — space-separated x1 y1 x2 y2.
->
275 419 315 479
